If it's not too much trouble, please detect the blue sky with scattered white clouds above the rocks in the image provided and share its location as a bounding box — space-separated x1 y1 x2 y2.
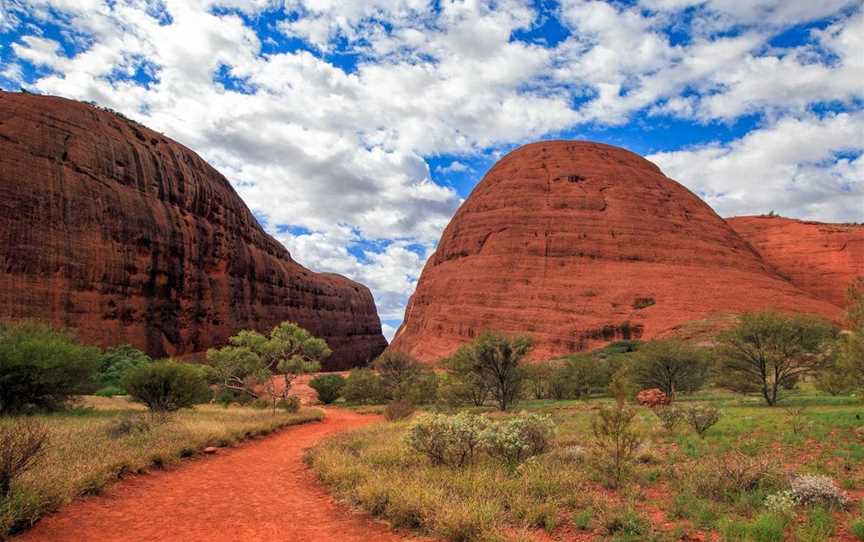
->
0 0 864 336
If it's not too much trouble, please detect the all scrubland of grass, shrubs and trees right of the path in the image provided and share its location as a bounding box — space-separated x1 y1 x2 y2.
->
307 282 864 542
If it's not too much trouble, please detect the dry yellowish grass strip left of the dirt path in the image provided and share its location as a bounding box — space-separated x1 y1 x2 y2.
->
0 397 323 538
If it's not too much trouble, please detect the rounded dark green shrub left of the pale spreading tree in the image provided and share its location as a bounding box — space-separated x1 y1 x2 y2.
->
123 360 211 412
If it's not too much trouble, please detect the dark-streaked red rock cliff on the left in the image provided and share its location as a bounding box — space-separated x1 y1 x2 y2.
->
0 92 387 369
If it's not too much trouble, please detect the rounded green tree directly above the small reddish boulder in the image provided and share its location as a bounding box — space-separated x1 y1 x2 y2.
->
633 339 709 399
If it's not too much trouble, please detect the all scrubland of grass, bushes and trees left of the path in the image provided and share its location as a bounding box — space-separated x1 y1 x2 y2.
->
0 322 329 538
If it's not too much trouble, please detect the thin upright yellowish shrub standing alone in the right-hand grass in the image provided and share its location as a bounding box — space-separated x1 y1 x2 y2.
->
591 398 642 487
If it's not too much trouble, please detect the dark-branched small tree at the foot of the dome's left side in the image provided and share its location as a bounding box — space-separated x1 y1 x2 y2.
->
448 332 532 411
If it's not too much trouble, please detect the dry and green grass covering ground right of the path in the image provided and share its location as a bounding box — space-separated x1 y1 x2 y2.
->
307 390 864 542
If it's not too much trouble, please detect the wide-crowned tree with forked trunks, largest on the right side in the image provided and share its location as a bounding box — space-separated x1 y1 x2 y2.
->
718 312 836 406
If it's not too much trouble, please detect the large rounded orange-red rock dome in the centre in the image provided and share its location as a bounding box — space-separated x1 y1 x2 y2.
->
391 141 839 361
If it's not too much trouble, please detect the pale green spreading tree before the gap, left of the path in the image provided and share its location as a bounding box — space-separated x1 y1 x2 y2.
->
207 322 331 413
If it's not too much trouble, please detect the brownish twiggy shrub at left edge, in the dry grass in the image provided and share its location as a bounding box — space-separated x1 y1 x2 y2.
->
0 419 48 498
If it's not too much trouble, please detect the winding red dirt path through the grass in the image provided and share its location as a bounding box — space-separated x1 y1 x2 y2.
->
16 410 418 542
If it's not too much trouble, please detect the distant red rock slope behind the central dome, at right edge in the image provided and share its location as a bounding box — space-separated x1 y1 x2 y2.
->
727 216 864 306
